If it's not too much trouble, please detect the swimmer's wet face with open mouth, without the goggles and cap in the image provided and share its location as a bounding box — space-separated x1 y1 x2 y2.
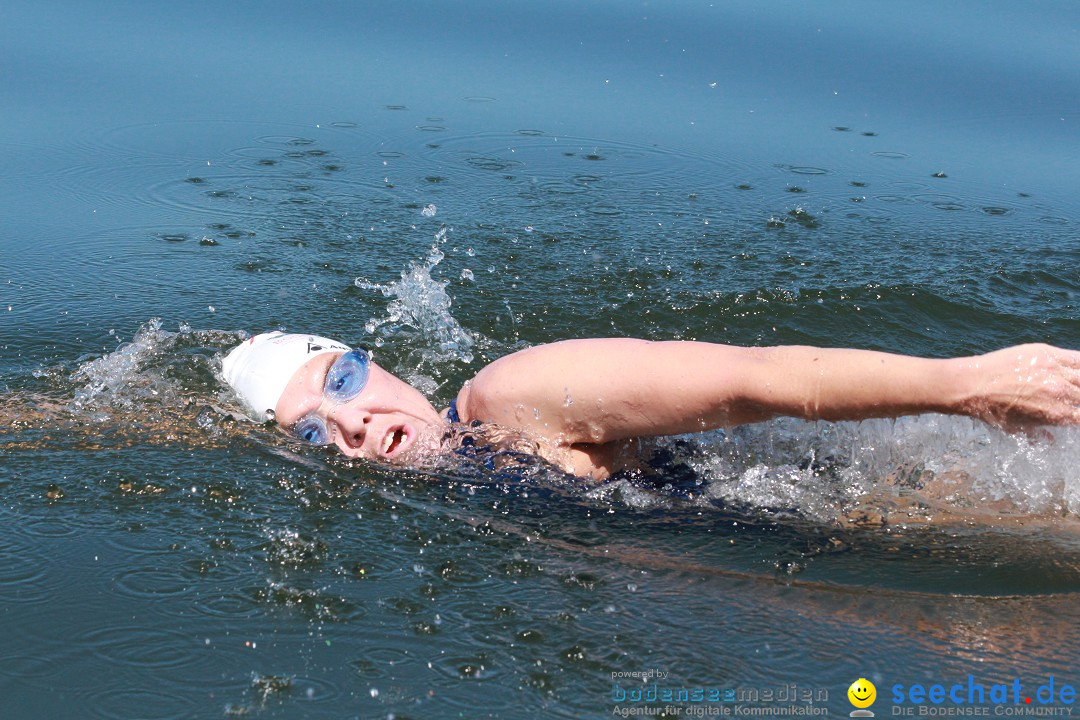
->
274 353 443 462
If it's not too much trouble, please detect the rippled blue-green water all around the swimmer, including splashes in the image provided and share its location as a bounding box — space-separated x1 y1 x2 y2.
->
0 0 1080 718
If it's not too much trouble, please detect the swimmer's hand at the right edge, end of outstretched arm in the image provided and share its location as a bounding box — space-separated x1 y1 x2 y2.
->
954 344 1080 432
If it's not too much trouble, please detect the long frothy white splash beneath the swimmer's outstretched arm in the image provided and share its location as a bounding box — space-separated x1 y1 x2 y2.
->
630 415 1080 522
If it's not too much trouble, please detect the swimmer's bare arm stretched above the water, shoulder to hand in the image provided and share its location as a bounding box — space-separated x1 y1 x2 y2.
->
459 339 1080 445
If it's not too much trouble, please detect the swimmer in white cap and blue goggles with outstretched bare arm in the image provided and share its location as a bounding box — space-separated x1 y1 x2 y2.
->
222 332 1080 479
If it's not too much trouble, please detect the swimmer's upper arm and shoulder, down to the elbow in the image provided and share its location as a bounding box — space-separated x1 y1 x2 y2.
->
459 338 759 446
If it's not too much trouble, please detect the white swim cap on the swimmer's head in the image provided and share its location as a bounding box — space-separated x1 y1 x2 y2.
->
221 331 351 422
